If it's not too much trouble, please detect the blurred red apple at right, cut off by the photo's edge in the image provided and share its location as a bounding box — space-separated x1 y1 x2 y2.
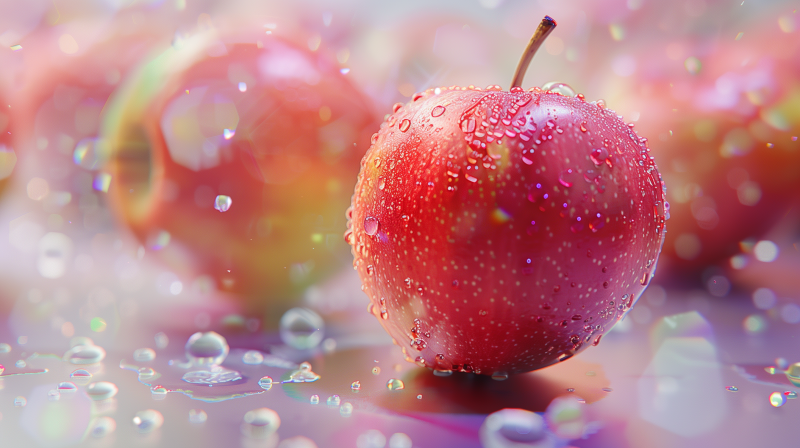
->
592 18 800 282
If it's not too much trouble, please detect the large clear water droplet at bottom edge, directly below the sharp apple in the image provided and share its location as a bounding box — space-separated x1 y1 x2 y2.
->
480 409 555 448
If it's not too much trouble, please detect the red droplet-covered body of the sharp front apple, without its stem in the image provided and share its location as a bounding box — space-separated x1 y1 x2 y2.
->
345 86 666 374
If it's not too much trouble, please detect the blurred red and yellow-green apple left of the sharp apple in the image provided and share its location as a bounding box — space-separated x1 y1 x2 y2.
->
104 34 375 316
